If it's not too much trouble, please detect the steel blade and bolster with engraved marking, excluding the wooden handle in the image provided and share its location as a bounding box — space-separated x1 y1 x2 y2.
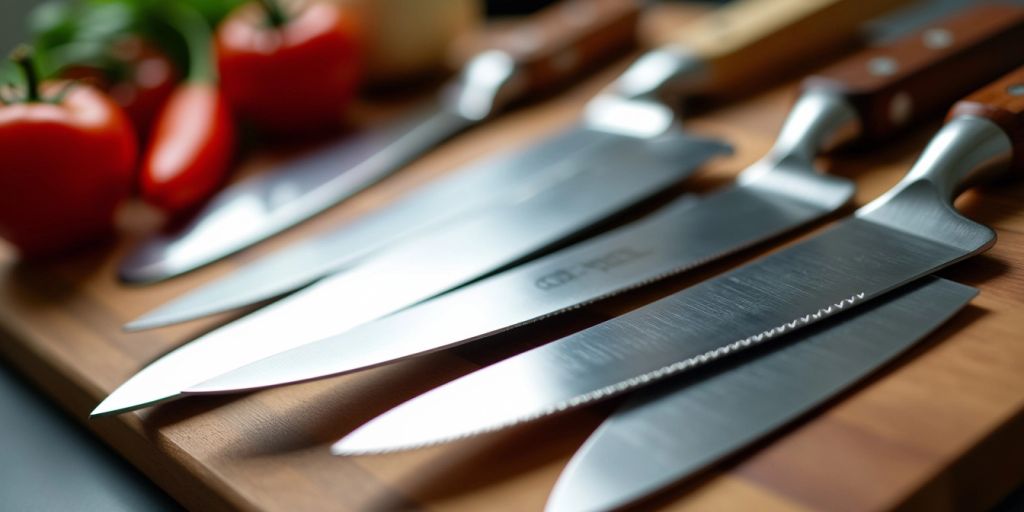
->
186 91 857 393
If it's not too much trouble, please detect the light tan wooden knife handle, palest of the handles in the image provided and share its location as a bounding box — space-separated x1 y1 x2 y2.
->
670 0 903 92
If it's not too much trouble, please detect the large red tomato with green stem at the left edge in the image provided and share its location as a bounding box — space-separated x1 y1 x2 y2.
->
0 84 137 257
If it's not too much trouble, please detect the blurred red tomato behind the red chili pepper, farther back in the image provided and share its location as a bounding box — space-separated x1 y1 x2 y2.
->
216 2 362 133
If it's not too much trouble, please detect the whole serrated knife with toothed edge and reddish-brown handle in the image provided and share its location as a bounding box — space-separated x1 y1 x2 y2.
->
325 69 1024 455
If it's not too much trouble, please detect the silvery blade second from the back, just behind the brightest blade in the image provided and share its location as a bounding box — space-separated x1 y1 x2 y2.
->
125 126 626 331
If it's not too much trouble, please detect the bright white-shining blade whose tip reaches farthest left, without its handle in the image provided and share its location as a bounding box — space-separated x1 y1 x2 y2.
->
94 132 723 414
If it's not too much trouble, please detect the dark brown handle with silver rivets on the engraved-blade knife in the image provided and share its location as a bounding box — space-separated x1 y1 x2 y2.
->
804 4 1024 139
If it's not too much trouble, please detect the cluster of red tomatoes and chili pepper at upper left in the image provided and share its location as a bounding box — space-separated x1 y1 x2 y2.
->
0 0 362 257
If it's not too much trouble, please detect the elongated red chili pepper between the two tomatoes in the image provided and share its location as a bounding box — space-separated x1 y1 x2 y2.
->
139 82 234 214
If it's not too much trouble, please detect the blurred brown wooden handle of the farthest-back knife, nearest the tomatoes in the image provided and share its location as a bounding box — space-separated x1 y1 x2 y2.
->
487 0 642 92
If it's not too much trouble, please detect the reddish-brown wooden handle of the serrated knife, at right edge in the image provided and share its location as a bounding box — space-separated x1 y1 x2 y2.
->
949 65 1024 169
